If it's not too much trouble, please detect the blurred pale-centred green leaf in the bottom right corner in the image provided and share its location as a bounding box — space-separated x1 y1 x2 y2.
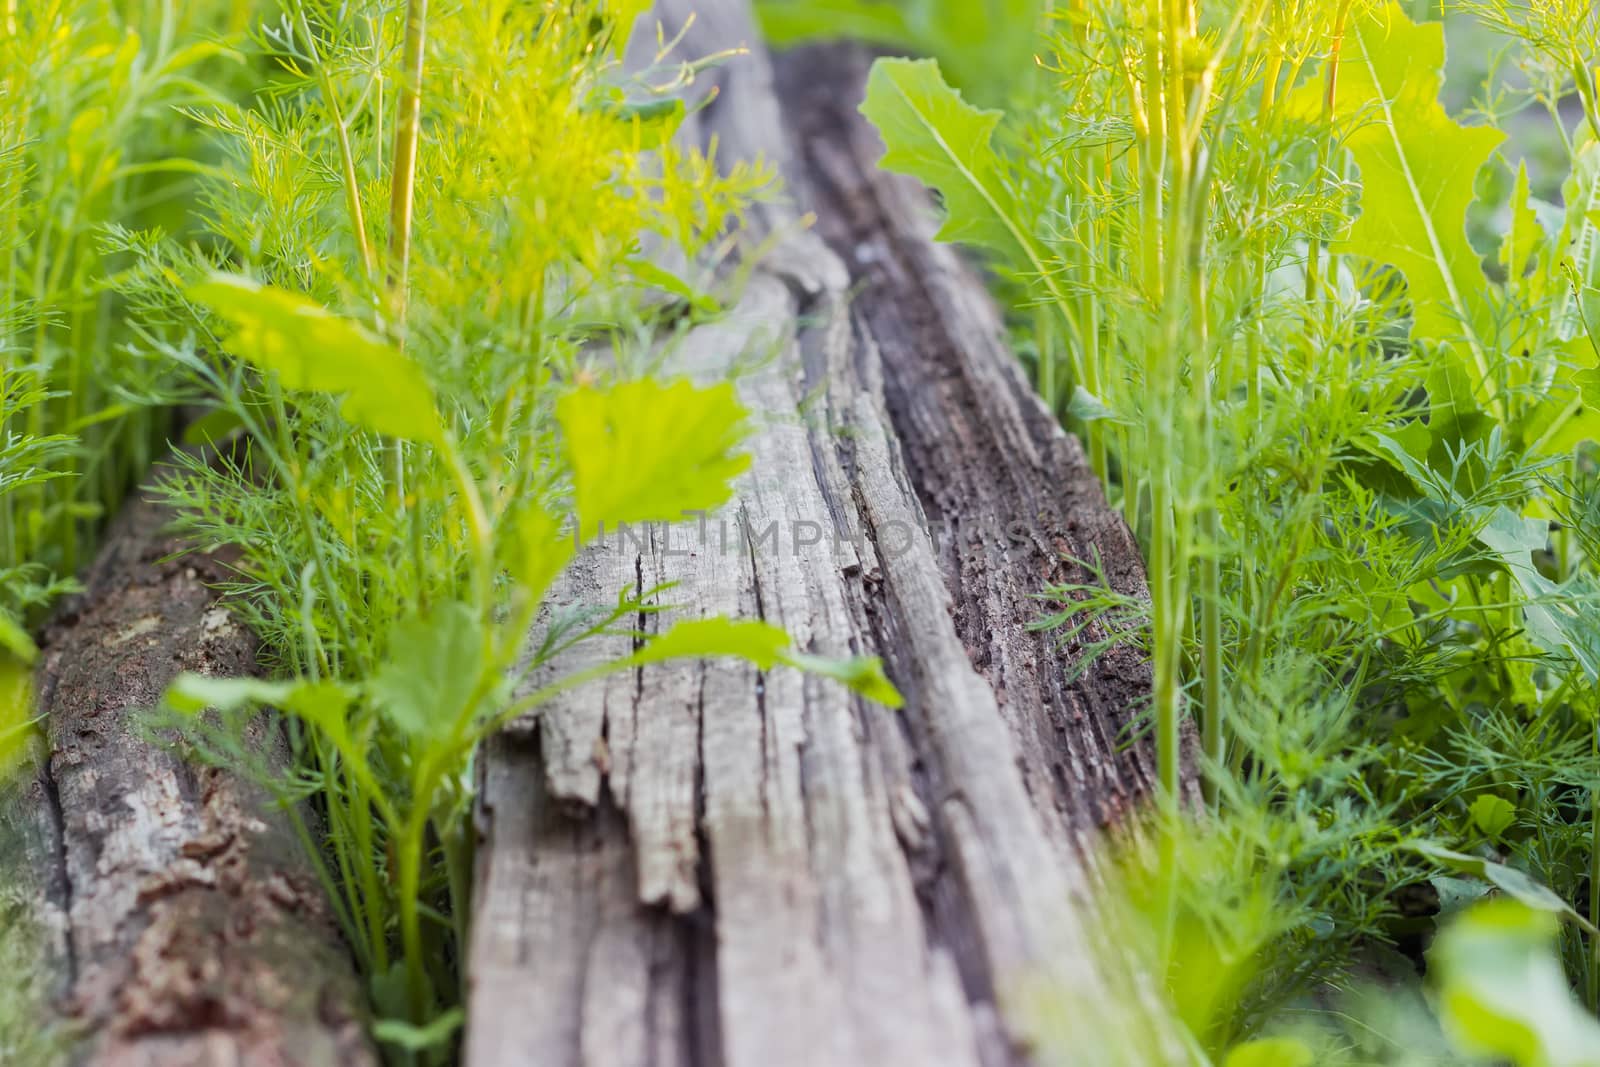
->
1427 899 1600 1067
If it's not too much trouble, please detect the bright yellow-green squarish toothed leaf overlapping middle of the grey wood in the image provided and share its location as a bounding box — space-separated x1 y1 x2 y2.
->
555 379 750 539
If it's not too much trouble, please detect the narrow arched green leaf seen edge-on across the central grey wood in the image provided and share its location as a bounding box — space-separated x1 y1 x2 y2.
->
634 616 904 707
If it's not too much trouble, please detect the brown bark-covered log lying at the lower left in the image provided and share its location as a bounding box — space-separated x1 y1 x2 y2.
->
19 501 376 1067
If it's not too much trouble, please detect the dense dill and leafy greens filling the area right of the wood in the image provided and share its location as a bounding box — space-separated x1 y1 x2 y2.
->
862 0 1600 1062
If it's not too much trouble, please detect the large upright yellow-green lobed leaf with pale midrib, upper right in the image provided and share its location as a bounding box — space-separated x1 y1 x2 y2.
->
1301 0 1506 400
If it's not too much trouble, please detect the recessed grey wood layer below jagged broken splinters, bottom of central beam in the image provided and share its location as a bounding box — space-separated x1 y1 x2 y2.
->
472 733 709 1067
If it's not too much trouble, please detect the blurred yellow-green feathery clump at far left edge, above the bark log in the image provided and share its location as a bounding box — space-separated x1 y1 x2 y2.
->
0 0 256 748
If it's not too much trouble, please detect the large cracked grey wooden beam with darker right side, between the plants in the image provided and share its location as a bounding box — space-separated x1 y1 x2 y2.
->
466 0 1190 1067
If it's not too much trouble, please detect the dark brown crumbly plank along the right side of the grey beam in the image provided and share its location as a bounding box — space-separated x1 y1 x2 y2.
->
778 41 1196 870
